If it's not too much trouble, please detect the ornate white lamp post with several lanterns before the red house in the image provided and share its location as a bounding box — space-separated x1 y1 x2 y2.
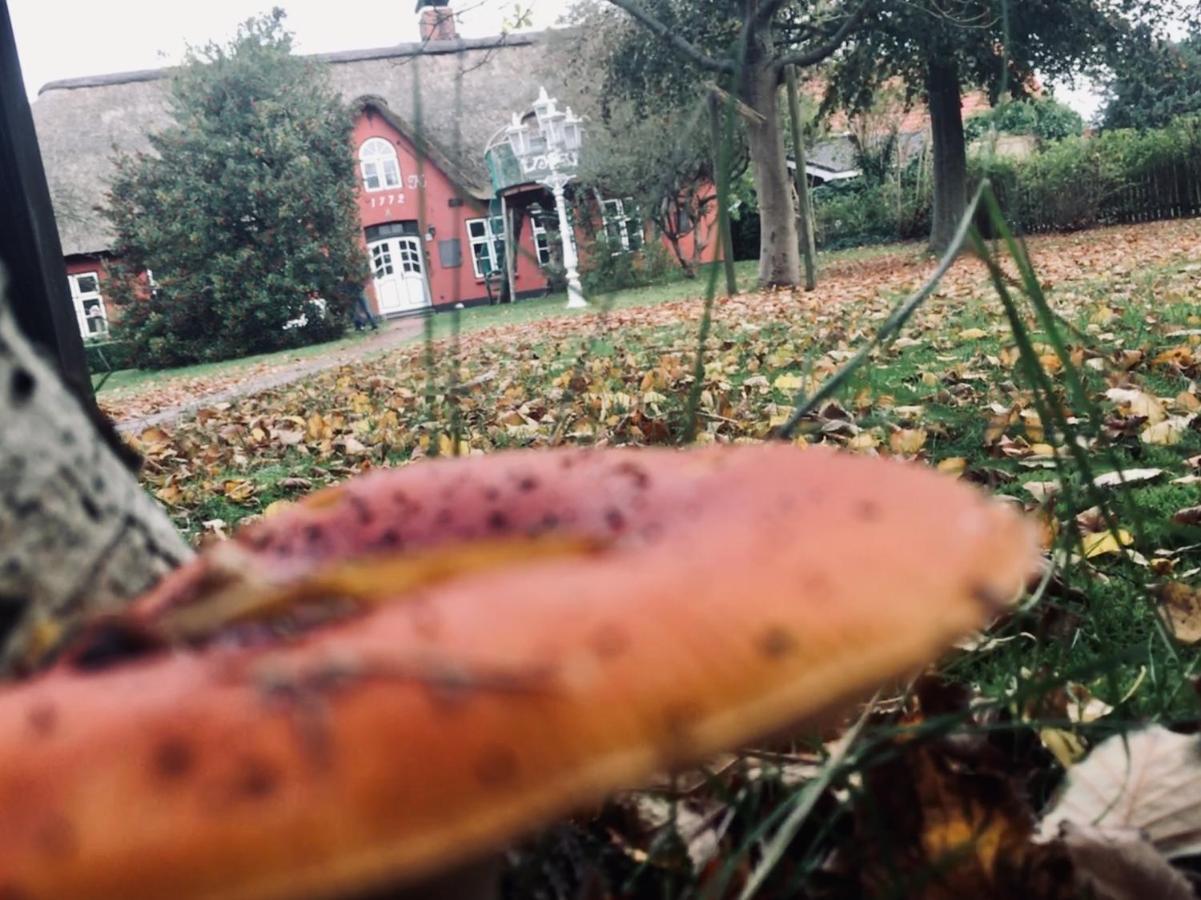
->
504 88 588 309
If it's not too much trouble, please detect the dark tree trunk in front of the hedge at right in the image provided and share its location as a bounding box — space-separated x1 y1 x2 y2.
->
926 58 968 254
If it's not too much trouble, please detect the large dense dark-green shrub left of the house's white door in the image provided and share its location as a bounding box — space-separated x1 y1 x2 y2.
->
107 11 368 368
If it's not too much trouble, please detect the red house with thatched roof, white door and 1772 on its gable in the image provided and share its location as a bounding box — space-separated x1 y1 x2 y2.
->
32 6 717 336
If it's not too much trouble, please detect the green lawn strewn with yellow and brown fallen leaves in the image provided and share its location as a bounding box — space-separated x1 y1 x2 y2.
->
121 213 1201 896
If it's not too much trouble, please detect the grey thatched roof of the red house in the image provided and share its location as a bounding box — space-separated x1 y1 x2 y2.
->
32 32 570 256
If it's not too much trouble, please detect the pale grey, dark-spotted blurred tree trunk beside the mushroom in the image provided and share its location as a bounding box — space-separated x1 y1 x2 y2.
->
0 291 191 673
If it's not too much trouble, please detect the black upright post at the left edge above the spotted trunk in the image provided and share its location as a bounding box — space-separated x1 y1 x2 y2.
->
0 0 95 409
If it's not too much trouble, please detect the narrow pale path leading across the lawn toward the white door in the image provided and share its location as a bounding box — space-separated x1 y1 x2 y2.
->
109 318 423 434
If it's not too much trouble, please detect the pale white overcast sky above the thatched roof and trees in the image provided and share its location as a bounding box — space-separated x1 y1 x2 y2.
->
8 0 1098 118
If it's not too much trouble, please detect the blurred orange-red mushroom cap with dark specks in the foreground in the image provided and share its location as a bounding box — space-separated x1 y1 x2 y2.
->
0 446 1038 900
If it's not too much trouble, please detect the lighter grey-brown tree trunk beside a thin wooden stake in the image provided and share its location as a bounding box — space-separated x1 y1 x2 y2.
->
743 60 801 287
